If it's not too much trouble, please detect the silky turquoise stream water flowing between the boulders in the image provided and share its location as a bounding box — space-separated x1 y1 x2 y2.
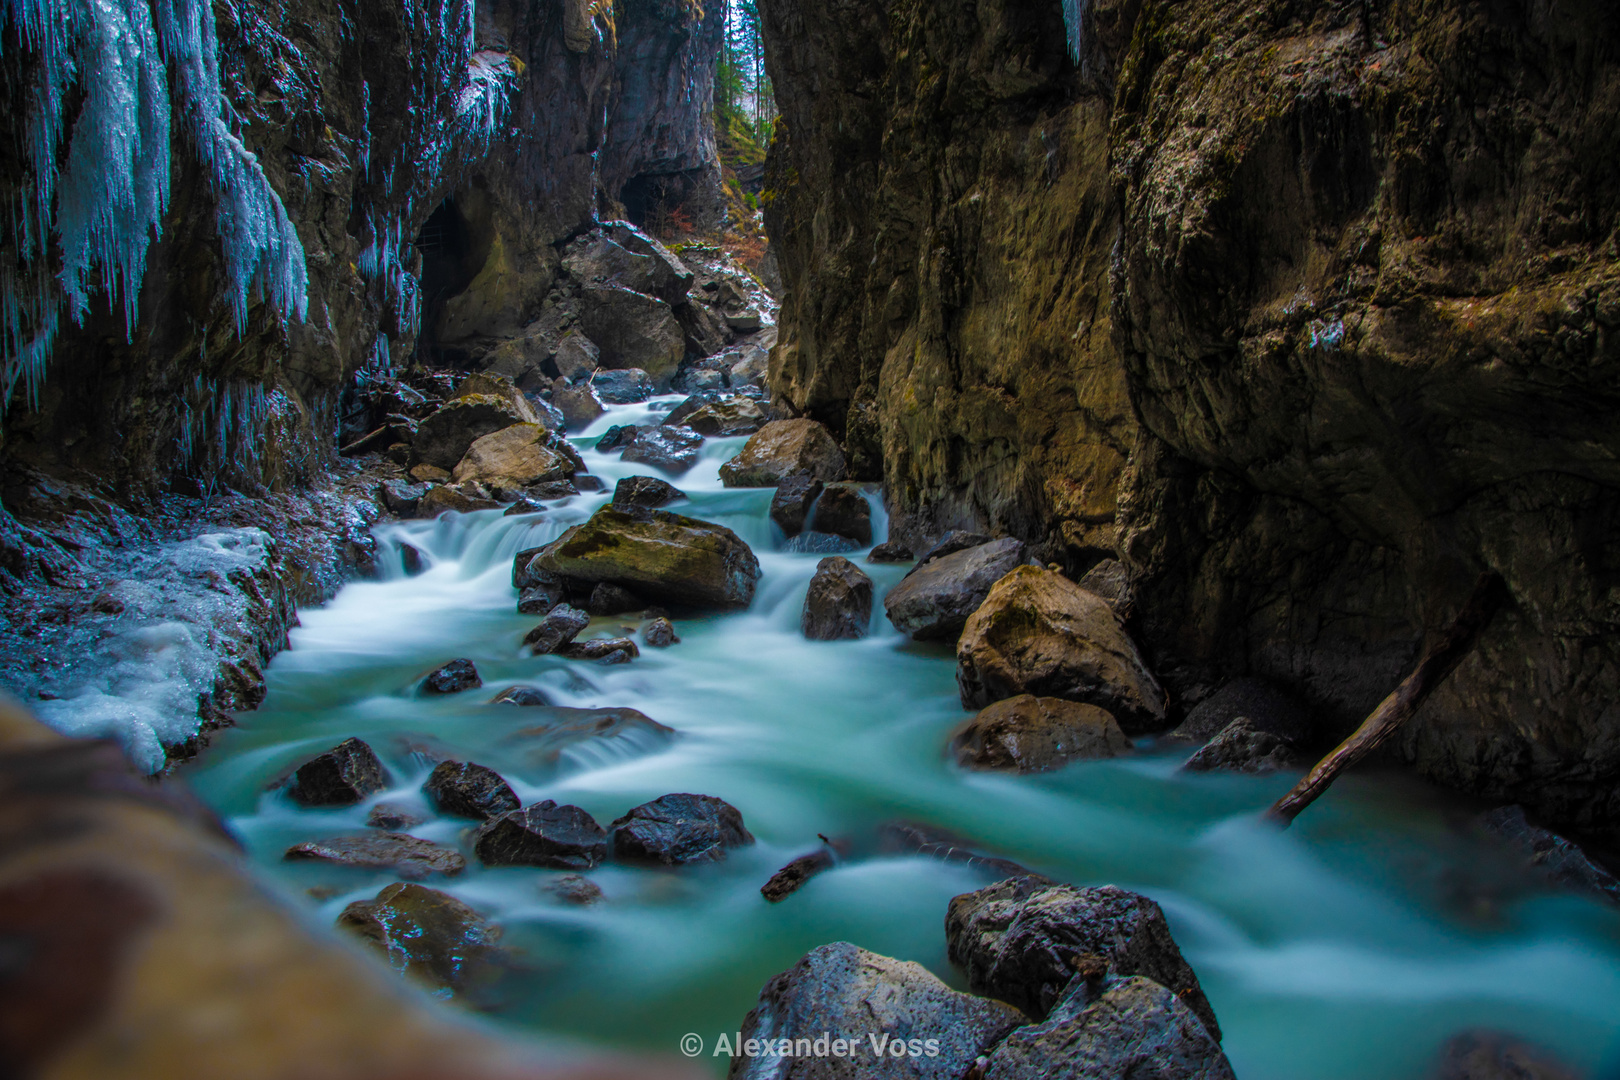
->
190 398 1620 1080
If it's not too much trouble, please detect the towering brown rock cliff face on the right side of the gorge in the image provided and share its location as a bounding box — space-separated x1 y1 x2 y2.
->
766 0 1620 824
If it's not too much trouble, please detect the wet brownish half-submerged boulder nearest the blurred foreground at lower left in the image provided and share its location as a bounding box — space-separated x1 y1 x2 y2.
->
337 882 501 991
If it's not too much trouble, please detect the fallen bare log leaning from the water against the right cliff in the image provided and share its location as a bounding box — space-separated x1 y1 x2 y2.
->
1265 572 1507 829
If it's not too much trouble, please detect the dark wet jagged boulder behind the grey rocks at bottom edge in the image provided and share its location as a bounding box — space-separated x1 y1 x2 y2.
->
944 876 1220 1041
